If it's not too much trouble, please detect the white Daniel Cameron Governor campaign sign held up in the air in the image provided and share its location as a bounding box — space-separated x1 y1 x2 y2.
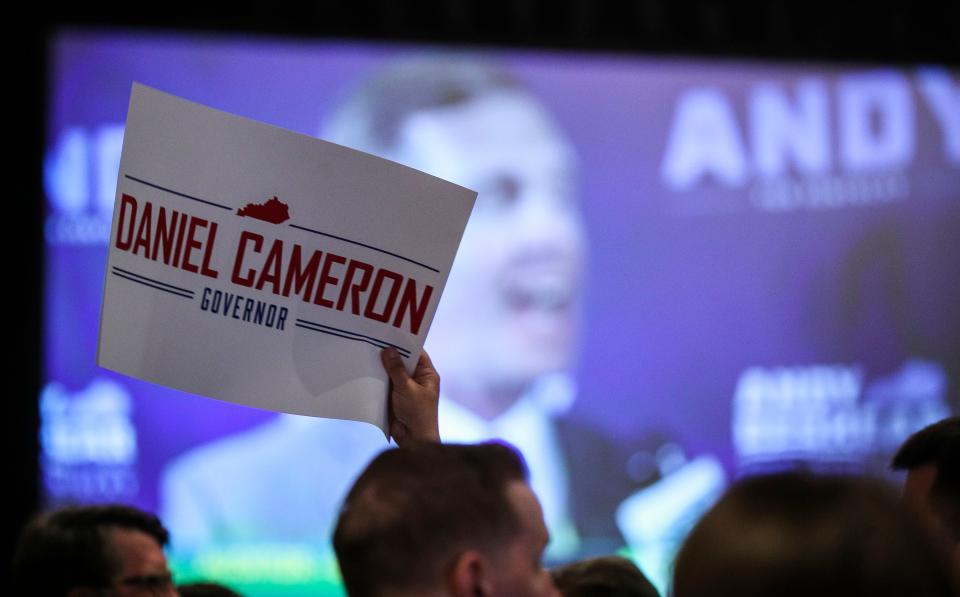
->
97 84 476 434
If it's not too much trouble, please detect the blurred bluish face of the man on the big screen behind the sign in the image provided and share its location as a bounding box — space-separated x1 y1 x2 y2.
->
401 91 584 418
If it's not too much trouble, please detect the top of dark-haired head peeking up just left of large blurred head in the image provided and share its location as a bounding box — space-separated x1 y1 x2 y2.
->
551 556 660 597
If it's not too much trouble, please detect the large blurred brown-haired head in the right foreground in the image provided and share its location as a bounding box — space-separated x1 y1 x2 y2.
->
673 473 956 597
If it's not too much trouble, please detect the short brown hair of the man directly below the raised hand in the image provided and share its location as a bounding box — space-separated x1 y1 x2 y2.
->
333 443 526 597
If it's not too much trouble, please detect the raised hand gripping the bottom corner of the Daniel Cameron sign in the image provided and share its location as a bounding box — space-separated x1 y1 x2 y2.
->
380 347 440 447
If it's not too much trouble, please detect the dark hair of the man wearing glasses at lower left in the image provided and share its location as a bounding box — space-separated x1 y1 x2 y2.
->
13 504 169 597
